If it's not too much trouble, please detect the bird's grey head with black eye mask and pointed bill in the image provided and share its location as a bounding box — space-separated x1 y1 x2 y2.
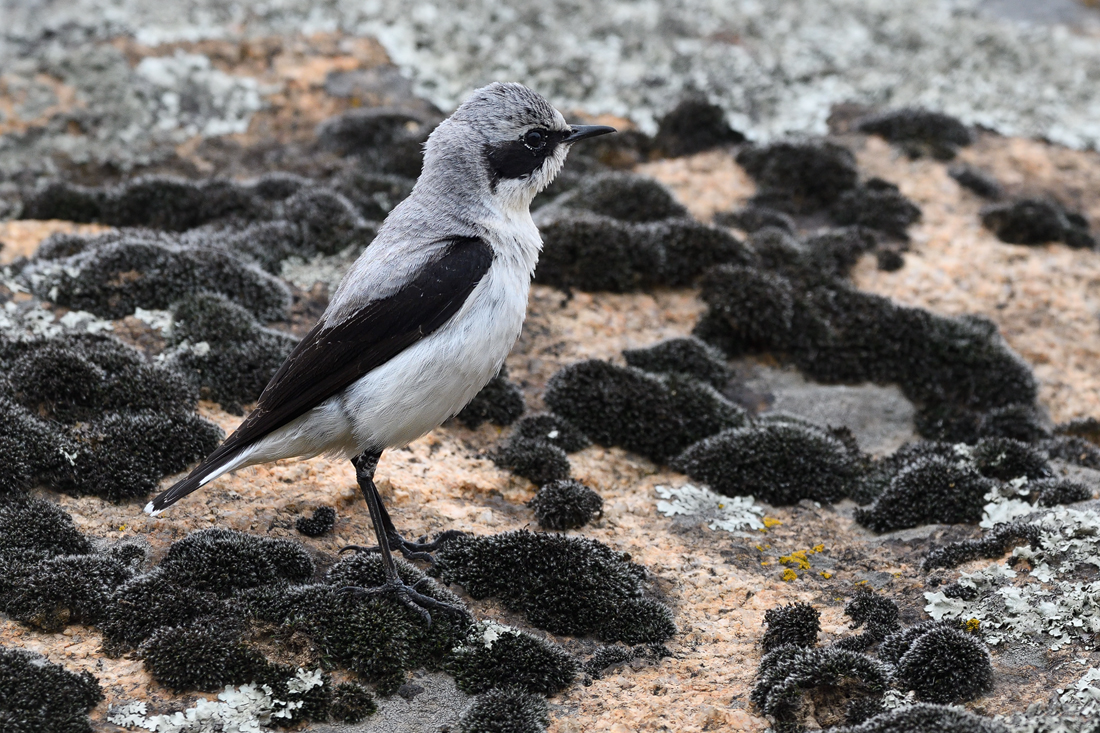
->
424 83 615 209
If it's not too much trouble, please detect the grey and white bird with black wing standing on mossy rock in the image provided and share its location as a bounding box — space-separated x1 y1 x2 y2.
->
145 83 616 625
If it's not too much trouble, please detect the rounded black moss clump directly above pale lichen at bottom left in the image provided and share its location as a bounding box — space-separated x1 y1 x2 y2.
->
139 619 266 692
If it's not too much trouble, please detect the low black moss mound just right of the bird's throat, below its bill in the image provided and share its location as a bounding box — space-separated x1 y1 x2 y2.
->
554 173 688 223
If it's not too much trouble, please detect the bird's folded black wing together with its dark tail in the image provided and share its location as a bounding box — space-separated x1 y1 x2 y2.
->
151 237 493 511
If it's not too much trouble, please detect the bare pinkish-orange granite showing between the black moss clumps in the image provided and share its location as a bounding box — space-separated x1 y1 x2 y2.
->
0 5 1100 733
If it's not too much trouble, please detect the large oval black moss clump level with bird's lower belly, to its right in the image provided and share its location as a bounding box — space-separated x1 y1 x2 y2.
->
545 360 746 461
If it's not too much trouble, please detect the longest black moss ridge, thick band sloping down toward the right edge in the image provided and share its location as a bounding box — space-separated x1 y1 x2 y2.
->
695 265 1037 440
